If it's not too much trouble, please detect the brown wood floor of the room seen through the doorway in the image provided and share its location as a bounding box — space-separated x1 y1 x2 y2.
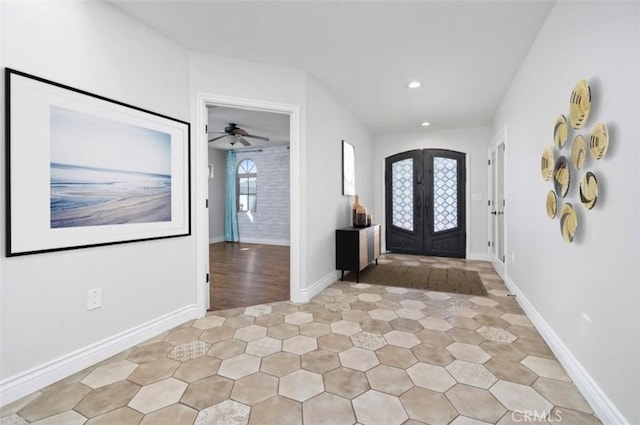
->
209 242 290 310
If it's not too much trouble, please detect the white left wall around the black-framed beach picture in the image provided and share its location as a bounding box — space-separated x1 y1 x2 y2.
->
0 2 196 404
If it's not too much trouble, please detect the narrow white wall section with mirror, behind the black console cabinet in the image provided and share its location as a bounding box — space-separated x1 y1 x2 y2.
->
304 77 374 286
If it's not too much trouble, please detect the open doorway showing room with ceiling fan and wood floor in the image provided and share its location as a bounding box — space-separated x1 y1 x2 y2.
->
207 105 291 310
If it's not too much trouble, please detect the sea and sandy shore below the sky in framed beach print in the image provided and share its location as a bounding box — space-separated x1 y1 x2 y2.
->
50 163 171 228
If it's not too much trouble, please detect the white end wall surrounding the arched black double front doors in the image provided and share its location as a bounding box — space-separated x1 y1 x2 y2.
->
373 127 491 259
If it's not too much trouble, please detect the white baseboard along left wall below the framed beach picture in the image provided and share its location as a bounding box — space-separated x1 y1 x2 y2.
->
0 304 198 406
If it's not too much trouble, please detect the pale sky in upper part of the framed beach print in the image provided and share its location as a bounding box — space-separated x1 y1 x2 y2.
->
50 105 171 175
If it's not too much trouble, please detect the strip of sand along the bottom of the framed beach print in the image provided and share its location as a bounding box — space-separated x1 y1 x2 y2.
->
51 192 171 227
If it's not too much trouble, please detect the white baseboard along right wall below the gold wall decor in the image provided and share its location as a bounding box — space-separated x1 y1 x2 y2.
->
504 275 630 425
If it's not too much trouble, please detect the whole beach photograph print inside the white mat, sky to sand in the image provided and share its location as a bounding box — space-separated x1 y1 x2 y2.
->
50 104 171 229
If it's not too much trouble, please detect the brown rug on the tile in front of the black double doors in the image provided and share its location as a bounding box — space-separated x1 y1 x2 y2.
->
344 264 487 297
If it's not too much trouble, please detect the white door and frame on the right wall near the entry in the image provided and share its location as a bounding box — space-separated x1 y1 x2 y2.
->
487 125 508 279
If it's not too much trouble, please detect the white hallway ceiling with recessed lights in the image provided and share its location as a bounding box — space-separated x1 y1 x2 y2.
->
110 0 553 134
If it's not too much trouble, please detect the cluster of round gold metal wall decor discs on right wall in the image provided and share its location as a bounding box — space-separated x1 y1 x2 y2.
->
540 79 610 243
